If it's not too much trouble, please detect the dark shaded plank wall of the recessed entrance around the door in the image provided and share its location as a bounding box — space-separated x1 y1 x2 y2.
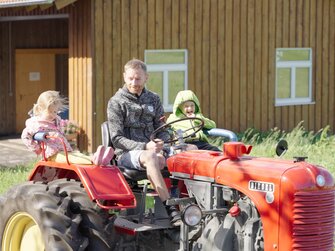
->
0 14 68 135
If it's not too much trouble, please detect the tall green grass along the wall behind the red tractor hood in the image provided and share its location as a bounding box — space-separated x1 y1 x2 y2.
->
211 122 335 177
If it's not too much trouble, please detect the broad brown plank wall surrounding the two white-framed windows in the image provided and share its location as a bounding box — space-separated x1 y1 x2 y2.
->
94 0 335 147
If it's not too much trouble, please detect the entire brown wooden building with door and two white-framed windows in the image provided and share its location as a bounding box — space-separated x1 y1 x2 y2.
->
0 0 335 151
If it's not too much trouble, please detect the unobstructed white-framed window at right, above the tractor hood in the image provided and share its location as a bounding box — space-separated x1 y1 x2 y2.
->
275 48 313 106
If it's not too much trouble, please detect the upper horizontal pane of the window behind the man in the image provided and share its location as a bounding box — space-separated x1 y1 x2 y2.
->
145 51 186 64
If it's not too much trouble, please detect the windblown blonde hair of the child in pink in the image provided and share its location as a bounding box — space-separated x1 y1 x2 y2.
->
33 91 68 116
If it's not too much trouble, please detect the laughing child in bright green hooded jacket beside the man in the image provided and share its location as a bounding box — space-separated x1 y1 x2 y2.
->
167 90 221 151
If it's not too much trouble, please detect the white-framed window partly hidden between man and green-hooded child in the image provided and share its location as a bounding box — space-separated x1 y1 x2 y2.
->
144 50 187 112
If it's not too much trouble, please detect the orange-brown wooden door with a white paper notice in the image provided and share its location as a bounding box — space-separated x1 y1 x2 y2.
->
15 49 55 133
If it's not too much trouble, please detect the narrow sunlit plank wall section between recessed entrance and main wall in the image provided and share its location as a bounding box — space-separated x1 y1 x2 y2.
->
69 0 92 152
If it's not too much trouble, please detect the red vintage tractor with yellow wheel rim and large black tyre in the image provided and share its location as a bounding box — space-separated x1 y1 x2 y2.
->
0 118 335 251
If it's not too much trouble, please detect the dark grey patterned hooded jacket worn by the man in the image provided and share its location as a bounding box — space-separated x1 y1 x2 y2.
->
107 86 169 157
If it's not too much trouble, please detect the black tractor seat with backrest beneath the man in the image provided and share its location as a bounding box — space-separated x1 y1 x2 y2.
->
101 121 170 181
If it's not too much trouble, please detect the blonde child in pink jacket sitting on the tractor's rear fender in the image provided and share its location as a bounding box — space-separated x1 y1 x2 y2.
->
21 91 114 165
